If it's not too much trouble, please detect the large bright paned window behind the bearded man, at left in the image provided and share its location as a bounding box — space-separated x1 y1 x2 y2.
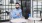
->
0 0 15 20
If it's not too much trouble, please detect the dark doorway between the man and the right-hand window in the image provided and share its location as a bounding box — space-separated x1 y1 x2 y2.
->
21 0 31 17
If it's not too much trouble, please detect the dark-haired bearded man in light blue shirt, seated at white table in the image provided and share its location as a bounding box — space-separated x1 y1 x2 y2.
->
10 3 22 19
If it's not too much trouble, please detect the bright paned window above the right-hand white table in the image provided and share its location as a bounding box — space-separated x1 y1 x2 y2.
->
33 1 42 18
